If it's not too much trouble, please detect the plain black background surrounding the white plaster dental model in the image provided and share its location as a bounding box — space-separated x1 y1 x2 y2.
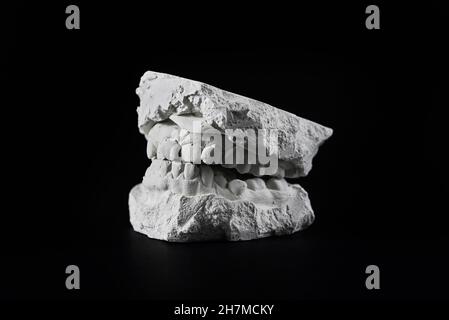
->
0 2 449 302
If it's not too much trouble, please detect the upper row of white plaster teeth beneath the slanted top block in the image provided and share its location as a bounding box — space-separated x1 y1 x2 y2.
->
147 129 285 178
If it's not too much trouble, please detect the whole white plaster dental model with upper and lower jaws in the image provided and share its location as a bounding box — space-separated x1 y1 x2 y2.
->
129 71 332 242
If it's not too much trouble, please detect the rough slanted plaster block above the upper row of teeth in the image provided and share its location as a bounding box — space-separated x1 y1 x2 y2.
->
136 71 332 177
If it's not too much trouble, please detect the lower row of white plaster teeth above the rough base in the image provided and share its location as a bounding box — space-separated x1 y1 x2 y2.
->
143 159 289 196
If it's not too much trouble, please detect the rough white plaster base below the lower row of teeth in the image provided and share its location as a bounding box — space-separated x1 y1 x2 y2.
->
129 184 315 242
